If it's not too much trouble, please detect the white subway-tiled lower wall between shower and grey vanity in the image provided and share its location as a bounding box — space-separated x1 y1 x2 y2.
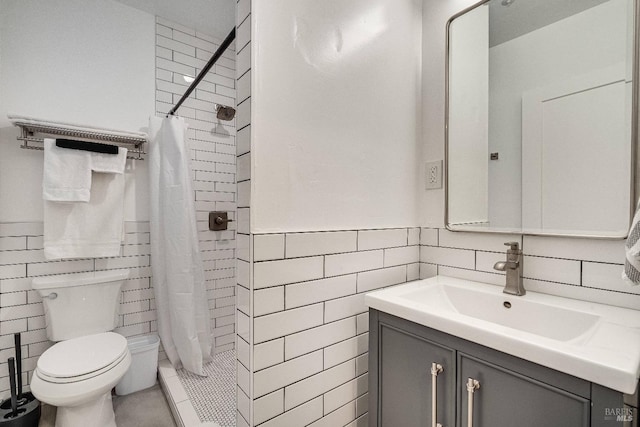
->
245 228 420 427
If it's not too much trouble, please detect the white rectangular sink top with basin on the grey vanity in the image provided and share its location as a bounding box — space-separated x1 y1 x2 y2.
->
365 276 640 394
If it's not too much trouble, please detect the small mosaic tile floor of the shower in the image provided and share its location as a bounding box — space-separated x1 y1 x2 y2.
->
177 350 236 427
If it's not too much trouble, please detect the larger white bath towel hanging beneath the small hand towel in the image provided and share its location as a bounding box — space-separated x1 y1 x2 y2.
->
44 171 125 259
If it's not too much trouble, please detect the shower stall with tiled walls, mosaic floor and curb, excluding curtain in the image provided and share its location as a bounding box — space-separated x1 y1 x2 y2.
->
152 18 237 427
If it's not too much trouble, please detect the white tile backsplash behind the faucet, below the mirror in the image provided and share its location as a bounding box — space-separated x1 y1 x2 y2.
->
420 228 640 309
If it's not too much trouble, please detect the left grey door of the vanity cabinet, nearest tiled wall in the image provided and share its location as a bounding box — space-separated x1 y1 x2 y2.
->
378 324 456 427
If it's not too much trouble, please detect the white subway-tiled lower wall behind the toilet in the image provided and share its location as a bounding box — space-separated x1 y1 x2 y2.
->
0 222 157 399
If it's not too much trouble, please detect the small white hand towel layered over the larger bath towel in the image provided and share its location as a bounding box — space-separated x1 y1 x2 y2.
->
42 139 92 202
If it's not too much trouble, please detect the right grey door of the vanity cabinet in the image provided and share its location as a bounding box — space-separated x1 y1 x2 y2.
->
456 352 590 427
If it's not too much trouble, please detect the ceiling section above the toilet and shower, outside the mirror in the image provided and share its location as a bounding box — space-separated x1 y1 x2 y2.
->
116 0 236 40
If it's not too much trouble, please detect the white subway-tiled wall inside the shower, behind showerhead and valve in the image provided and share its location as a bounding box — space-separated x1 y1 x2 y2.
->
156 18 237 353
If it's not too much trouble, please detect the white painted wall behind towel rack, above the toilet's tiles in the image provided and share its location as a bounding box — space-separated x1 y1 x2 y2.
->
0 0 155 222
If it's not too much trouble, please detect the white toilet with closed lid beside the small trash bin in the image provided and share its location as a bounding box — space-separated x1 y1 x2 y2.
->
30 269 131 427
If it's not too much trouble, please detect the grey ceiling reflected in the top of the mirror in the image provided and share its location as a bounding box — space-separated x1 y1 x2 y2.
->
489 0 609 46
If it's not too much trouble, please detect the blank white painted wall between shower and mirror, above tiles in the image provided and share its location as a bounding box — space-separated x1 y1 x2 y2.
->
251 0 422 232
